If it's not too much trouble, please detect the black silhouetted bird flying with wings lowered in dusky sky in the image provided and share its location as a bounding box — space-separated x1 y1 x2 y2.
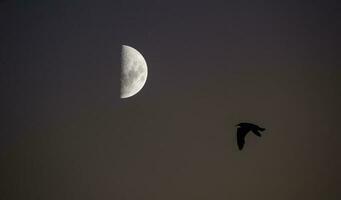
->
236 122 265 150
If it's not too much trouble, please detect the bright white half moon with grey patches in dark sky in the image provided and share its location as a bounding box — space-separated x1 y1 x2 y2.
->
120 45 148 98
